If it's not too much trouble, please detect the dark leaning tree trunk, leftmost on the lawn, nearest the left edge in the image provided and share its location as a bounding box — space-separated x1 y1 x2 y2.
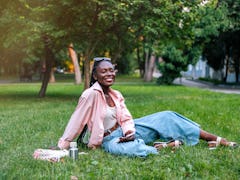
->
38 36 54 98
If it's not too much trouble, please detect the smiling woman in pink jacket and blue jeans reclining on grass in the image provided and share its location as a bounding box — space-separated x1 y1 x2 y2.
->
58 58 237 157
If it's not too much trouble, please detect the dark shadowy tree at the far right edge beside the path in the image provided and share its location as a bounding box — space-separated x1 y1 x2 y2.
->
203 0 240 82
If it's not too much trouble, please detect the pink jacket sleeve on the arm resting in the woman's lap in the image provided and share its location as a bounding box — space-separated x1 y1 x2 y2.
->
119 92 136 134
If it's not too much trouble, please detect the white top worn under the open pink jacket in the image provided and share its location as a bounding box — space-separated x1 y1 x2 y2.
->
103 106 117 132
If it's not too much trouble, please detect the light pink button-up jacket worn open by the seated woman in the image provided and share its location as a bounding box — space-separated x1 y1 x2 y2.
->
58 82 135 149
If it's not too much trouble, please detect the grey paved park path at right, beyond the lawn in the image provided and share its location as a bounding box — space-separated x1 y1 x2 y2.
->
174 78 240 94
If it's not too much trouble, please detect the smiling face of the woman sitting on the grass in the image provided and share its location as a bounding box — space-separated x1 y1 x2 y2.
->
95 61 116 87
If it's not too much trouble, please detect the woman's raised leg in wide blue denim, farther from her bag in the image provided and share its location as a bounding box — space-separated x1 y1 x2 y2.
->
134 111 200 146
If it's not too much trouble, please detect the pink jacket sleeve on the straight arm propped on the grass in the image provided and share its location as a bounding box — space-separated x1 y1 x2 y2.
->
58 96 91 149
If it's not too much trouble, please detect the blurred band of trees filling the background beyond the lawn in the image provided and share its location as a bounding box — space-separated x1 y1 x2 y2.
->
0 0 240 97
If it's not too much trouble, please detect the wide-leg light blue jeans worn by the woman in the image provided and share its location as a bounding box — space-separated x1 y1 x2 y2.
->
102 111 200 157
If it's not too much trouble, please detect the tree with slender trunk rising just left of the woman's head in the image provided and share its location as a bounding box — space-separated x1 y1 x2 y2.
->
42 0 142 88
